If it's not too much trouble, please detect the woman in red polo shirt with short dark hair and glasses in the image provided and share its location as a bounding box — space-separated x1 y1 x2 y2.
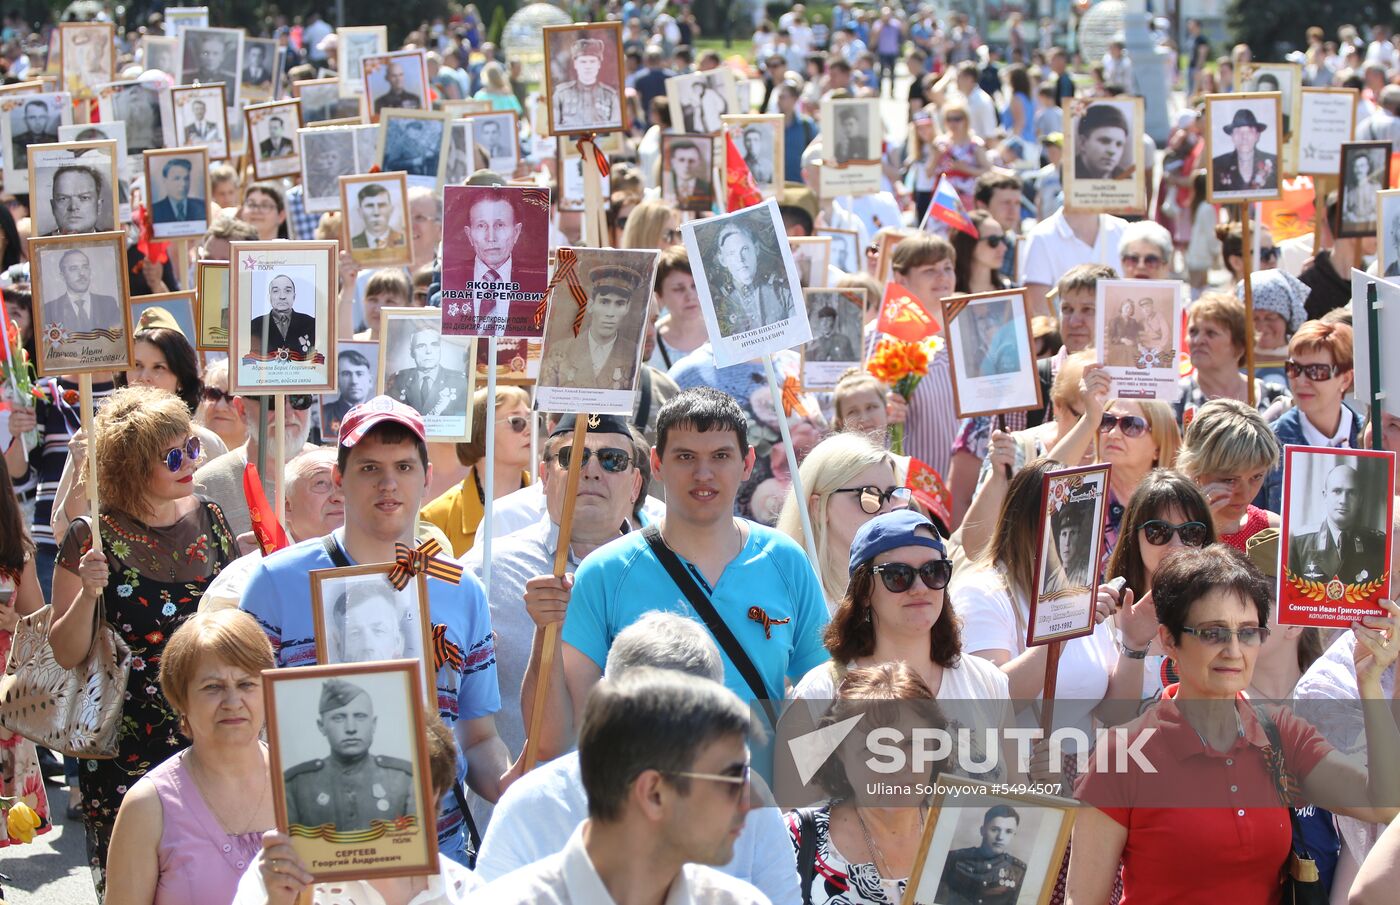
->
1068 544 1400 905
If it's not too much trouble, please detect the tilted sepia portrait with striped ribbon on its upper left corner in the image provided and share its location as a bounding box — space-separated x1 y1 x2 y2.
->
535 248 657 416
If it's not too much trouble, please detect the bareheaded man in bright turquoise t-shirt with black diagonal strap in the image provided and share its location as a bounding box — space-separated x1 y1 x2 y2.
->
521 387 827 758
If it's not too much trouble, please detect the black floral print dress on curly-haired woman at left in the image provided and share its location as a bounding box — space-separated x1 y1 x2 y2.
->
59 500 238 897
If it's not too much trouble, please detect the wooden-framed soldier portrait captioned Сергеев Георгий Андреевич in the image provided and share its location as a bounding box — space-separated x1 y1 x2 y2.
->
263 660 438 883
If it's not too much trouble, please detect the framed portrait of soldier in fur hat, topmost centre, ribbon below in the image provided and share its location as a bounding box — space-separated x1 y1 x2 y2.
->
545 21 624 136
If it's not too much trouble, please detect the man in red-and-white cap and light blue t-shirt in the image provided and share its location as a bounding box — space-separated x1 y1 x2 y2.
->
239 396 508 863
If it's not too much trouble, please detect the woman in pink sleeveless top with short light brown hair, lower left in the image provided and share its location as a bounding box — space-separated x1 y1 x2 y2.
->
106 609 274 905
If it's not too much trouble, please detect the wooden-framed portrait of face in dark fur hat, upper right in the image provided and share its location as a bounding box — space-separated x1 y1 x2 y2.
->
1063 97 1151 214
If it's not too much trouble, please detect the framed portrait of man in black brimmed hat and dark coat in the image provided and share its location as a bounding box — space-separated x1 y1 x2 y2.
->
1205 91 1282 205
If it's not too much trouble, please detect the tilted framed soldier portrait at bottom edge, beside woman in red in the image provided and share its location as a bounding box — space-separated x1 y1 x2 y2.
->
904 773 1077 905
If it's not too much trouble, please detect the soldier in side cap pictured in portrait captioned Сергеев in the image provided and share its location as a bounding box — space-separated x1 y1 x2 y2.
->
283 679 414 832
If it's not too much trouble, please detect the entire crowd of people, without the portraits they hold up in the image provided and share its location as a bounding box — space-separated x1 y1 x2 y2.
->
0 0 1400 905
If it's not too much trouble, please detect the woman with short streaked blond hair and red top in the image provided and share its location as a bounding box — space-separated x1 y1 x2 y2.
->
1176 399 1278 552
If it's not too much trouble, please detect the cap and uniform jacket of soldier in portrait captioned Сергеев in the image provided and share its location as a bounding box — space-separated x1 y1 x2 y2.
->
283 679 414 832
